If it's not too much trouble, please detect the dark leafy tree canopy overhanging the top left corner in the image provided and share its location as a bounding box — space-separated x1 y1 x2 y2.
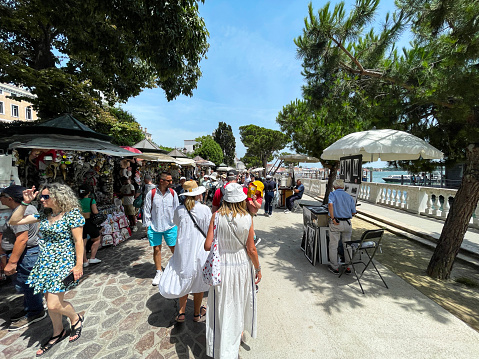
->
0 0 209 118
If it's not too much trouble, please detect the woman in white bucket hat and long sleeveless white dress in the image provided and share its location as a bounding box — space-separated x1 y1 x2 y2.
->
205 183 261 359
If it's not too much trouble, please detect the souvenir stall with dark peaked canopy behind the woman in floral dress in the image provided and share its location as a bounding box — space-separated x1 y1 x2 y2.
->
0 115 141 245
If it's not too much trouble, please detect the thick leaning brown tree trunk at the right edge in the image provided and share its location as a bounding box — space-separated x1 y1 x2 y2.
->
427 145 479 279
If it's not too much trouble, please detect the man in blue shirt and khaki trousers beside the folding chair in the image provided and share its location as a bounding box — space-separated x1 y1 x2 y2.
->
328 179 356 274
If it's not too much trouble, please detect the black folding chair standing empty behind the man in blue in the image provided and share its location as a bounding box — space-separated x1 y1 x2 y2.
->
339 229 389 294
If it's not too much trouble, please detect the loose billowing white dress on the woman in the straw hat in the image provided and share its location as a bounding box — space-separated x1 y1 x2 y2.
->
158 201 211 299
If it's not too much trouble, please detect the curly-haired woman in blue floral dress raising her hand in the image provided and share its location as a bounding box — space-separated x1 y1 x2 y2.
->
10 183 85 357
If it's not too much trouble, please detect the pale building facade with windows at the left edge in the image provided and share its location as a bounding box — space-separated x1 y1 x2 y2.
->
0 83 37 122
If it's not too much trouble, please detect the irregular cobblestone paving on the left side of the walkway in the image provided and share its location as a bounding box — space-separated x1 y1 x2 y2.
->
0 231 208 359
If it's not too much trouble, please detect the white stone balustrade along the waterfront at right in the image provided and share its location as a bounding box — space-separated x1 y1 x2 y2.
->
302 178 479 228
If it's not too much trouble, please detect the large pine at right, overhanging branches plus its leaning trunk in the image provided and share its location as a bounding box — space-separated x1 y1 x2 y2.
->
284 0 479 278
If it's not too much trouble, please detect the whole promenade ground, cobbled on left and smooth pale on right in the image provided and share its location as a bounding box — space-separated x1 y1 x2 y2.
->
0 198 479 359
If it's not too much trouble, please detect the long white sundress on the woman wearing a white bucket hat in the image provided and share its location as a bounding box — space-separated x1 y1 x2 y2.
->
206 213 257 359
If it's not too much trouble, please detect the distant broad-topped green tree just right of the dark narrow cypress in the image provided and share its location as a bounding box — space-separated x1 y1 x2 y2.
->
239 125 289 173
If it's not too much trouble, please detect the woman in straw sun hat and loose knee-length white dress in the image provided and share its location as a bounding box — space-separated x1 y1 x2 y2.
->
158 181 211 323
